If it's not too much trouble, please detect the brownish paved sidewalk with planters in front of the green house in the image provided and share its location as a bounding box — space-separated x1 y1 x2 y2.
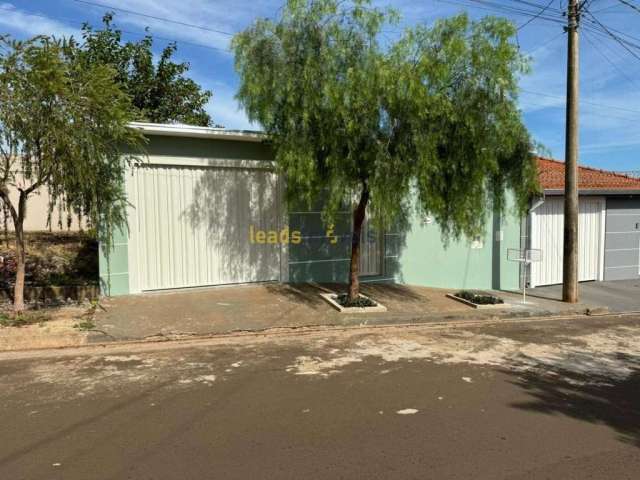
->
89 284 602 342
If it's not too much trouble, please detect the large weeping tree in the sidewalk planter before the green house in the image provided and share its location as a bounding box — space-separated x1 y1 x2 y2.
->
232 0 537 302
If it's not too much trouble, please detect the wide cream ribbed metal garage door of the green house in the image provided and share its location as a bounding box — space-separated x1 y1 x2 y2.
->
134 161 280 290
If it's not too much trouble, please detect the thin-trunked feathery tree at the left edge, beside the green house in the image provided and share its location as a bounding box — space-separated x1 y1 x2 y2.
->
0 37 142 312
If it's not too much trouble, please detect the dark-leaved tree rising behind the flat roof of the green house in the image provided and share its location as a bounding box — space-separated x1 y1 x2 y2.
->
81 13 212 126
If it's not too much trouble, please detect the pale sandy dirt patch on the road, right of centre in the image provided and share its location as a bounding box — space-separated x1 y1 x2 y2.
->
287 326 640 385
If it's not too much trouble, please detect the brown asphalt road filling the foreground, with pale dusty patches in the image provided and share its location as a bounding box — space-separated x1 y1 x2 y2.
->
0 317 640 480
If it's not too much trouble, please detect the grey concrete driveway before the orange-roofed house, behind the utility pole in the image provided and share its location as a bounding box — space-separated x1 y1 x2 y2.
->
529 280 640 312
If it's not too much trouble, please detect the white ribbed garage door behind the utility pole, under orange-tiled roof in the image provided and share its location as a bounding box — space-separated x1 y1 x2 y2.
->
531 197 605 287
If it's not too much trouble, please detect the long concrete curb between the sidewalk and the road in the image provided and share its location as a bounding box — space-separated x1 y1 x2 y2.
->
0 311 640 361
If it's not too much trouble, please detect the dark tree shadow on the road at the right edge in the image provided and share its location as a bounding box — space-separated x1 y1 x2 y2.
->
512 352 640 448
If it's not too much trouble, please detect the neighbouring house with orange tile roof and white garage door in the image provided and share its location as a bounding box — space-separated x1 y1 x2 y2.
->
525 158 640 287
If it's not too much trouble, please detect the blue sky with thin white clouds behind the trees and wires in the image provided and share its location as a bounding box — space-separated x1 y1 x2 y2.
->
0 0 640 171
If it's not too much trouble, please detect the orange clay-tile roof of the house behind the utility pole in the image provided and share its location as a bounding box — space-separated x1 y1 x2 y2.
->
538 157 640 192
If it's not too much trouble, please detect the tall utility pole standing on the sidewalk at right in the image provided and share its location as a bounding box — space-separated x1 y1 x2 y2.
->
562 0 580 303
